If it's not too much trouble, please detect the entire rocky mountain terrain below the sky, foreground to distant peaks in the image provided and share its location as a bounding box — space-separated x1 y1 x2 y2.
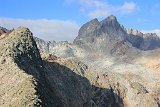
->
0 16 160 107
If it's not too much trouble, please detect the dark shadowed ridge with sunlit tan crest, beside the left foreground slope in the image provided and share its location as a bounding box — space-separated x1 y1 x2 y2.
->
41 56 124 107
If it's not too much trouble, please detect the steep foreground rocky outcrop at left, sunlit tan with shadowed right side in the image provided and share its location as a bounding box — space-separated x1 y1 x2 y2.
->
0 28 47 107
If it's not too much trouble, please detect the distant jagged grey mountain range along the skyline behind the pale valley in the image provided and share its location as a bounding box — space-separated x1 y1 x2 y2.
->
35 15 160 57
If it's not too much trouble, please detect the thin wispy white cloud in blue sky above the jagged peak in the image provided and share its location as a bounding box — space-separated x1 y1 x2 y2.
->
80 0 138 18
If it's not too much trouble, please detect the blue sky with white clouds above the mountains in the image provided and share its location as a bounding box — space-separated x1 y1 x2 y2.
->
0 0 160 41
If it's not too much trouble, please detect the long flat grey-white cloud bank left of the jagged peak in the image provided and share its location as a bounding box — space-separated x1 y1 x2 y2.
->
0 18 79 41
